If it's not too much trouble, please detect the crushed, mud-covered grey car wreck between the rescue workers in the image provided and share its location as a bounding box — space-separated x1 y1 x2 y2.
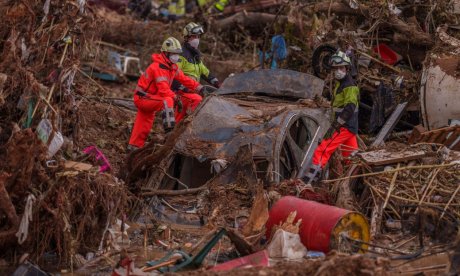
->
127 70 329 223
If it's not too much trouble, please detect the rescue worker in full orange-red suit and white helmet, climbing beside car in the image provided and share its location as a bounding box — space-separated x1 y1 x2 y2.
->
128 37 203 151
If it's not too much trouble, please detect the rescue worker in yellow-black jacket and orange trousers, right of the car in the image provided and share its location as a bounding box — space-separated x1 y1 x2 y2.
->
301 51 359 184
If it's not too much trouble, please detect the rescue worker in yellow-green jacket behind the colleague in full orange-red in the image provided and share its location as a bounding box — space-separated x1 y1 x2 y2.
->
172 22 220 123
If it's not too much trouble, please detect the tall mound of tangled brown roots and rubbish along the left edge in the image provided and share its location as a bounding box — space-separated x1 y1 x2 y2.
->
0 0 133 267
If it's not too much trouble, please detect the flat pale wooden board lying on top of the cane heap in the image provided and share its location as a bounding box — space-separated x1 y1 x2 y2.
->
357 149 427 166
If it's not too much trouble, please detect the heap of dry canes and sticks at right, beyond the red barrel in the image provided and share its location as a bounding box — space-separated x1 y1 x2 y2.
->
348 144 460 241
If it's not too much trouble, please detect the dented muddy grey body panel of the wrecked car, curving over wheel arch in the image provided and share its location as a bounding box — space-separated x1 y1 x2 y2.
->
175 96 328 160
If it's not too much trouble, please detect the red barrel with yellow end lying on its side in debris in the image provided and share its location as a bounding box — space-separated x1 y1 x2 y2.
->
266 196 369 253
